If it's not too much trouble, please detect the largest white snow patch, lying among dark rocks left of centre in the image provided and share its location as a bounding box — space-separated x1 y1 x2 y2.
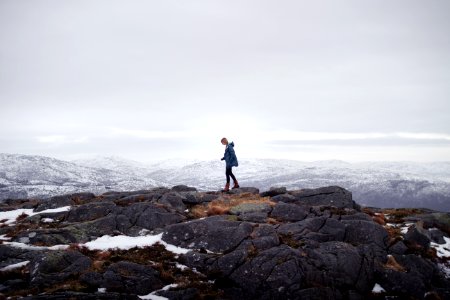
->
84 233 191 254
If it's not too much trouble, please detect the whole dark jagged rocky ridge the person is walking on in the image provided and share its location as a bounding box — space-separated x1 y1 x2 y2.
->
0 186 450 299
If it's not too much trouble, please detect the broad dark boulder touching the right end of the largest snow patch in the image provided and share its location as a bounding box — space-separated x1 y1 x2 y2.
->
162 216 253 252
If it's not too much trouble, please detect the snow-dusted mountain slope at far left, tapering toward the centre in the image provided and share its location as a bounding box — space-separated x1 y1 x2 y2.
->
0 154 163 199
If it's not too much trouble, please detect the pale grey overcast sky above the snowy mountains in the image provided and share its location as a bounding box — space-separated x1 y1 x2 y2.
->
0 0 450 161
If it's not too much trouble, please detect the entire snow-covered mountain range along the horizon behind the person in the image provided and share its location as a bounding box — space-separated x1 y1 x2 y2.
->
0 154 450 211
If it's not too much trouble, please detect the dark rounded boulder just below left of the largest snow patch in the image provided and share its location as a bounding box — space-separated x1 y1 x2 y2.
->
29 251 91 288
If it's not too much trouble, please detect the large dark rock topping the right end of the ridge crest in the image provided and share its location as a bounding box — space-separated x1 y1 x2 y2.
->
289 186 359 209
